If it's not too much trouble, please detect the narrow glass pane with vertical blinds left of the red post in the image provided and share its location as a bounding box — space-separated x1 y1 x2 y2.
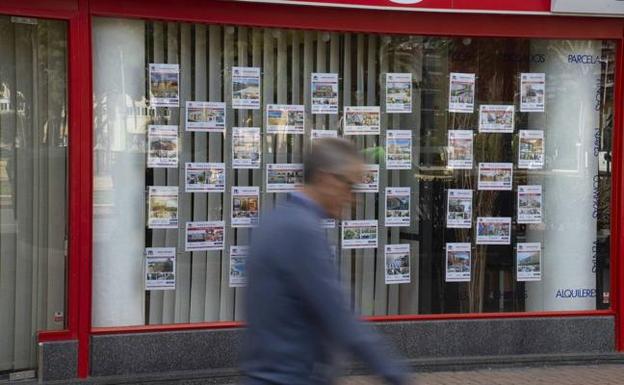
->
0 16 67 372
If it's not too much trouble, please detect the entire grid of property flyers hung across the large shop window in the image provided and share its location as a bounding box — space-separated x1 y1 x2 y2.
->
145 64 545 290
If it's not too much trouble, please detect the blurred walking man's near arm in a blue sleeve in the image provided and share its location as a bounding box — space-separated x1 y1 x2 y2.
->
289 222 407 384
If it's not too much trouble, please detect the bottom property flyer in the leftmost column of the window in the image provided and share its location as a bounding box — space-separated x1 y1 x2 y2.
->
145 247 176 290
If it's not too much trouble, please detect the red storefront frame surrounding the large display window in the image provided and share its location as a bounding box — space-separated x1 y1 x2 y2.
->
0 0 624 378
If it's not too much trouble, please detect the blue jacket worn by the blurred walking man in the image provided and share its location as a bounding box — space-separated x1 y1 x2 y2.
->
242 193 405 385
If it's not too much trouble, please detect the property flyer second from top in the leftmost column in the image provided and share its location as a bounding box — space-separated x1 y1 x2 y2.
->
147 125 178 168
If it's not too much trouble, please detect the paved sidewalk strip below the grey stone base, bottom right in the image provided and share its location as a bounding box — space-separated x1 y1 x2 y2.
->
340 365 624 385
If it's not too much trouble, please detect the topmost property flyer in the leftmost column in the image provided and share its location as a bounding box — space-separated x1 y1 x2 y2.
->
149 63 180 107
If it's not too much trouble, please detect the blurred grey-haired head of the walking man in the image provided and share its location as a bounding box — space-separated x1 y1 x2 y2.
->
304 138 363 218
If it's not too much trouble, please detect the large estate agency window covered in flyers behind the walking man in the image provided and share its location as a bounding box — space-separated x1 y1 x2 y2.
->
93 19 615 326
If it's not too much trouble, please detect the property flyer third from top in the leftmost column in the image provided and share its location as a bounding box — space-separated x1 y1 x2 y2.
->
147 186 178 229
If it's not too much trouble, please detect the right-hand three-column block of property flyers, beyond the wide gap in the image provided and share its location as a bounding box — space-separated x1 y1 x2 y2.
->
445 73 546 282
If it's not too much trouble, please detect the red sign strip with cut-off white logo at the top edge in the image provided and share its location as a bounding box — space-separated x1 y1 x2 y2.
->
240 0 552 13
